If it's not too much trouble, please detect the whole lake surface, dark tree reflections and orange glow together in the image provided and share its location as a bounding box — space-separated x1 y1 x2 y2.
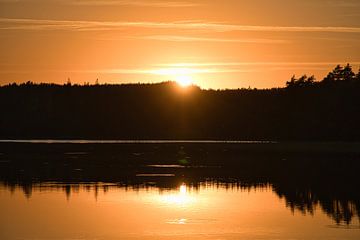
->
0 142 360 240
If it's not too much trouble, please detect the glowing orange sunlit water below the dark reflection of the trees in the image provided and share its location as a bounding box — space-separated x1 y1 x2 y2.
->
0 184 360 239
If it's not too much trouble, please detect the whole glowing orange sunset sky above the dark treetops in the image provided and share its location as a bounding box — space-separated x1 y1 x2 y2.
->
0 0 360 88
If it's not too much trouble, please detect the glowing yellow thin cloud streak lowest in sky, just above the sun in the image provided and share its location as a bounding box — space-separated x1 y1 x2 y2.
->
0 61 360 77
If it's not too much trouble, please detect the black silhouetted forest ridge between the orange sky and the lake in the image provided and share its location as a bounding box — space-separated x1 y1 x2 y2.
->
0 64 360 141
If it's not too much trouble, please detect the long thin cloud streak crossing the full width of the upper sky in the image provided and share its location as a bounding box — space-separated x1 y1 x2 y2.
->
0 18 360 33
